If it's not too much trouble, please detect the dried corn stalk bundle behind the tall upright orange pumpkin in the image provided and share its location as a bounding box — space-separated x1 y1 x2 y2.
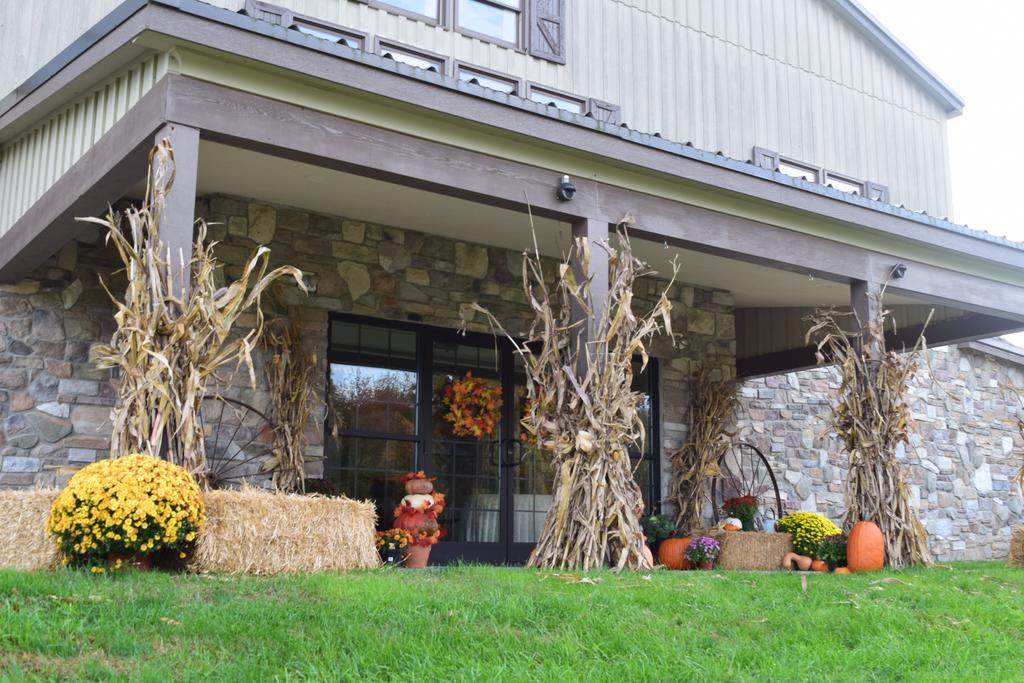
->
807 292 932 567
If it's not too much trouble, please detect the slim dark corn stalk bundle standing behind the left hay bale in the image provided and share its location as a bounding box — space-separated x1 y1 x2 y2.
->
263 323 321 493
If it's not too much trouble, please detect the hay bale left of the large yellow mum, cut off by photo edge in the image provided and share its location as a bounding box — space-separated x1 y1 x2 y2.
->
0 489 60 571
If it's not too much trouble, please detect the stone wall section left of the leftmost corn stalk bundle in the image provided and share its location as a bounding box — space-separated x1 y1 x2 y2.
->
0 236 118 487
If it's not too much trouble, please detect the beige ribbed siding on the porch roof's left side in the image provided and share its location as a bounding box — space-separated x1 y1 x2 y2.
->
0 55 167 234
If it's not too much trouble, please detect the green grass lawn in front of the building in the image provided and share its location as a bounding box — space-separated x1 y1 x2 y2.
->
0 562 1024 683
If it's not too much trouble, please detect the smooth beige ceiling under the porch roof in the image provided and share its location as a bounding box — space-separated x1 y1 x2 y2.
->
186 141 880 307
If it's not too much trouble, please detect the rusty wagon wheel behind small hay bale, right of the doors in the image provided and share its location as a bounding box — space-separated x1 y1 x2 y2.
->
709 441 782 524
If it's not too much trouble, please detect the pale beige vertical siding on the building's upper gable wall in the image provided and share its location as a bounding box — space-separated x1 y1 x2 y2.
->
0 0 950 216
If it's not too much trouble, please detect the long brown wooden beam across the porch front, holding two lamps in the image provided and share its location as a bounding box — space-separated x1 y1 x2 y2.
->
157 75 1024 322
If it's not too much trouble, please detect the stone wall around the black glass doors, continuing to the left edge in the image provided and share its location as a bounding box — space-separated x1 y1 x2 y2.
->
0 192 735 497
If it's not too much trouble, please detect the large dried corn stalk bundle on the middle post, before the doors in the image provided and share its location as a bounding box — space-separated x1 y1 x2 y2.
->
474 224 675 569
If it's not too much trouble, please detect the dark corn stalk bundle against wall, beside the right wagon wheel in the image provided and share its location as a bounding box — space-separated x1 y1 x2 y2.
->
672 368 736 531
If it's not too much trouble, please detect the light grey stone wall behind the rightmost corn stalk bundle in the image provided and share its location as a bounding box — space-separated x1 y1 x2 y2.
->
737 347 1024 560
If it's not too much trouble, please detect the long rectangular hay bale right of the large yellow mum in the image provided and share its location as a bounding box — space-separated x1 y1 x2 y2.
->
189 487 380 574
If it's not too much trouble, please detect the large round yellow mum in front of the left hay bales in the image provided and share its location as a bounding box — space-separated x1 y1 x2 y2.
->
46 455 204 567
